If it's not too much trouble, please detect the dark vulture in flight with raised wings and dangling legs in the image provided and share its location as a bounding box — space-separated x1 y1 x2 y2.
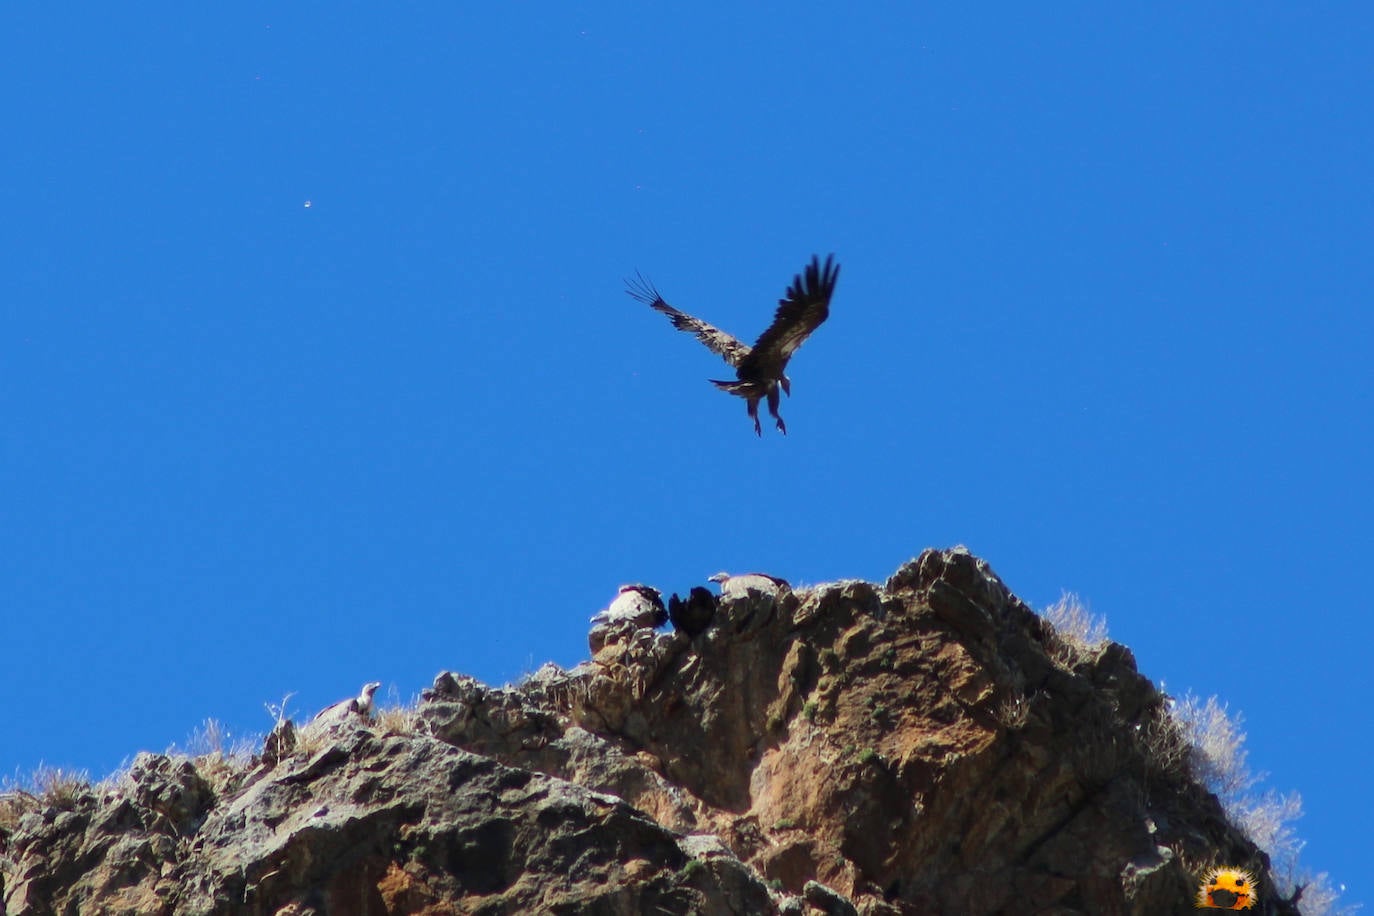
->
625 254 840 435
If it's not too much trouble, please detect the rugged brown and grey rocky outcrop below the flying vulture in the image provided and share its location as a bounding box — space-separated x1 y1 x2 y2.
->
0 549 1297 916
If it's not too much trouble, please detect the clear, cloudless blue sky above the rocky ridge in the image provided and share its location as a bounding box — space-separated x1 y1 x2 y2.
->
0 3 1374 902
